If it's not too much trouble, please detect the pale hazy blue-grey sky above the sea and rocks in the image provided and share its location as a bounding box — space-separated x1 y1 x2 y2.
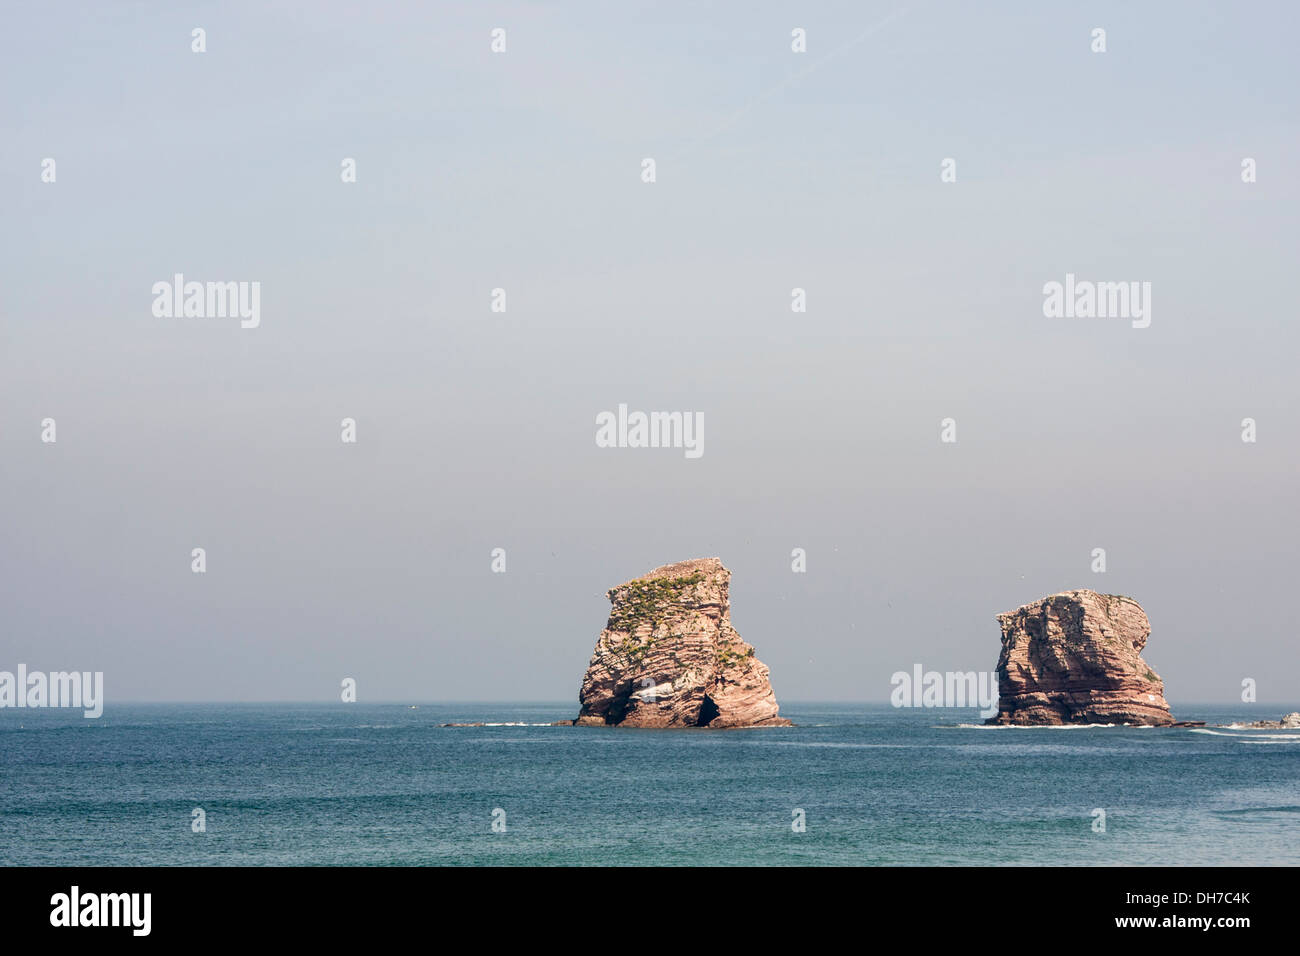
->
0 0 1300 715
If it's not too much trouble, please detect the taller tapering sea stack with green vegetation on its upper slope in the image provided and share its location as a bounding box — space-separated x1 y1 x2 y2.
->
575 558 790 727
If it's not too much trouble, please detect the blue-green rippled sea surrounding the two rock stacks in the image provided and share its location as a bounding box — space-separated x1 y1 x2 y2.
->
0 704 1300 865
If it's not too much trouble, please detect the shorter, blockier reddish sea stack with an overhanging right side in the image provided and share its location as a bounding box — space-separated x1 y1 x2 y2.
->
988 591 1174 726
